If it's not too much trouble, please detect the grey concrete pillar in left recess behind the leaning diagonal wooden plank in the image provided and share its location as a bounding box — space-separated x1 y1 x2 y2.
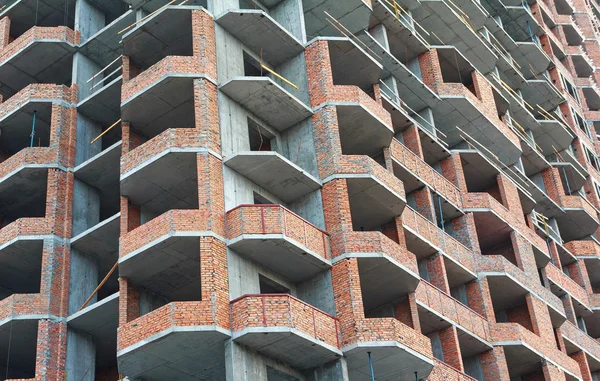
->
69 249 99 315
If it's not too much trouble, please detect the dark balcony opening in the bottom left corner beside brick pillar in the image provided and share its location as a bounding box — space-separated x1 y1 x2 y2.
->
0 320 38 380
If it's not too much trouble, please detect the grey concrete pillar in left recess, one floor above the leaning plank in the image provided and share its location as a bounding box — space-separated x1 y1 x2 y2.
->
73 178 100 236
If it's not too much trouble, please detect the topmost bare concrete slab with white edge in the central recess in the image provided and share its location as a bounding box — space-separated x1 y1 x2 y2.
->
216 9 304 67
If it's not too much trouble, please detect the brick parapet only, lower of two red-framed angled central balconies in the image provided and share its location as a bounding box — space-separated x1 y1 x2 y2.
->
231 294 340 348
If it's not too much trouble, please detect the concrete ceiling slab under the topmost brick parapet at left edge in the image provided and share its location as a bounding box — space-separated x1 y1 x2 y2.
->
0 39 76 96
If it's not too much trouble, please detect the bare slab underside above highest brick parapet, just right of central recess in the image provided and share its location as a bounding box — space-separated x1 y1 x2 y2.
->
325 37 383 93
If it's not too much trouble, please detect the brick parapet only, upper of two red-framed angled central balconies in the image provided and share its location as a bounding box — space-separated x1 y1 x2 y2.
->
226 205 331 259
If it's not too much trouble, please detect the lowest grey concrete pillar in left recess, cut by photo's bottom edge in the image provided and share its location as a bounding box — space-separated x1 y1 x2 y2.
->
66 329 96 381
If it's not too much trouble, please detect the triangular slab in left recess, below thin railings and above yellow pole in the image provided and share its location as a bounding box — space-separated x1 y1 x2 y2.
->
77 75 123 127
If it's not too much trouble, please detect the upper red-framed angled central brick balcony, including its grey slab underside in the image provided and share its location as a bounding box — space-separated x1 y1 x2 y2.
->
227 205 331 282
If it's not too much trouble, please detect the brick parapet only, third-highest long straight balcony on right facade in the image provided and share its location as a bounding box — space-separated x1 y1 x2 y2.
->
415 280 491 341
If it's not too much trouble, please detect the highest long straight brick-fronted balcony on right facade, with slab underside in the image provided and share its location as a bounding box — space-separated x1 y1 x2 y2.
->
390 139 462 215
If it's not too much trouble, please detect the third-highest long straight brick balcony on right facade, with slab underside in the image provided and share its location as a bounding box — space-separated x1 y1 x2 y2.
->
416 280 492 357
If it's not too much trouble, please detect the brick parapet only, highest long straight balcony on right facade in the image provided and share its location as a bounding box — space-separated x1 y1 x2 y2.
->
390 139 462 209
